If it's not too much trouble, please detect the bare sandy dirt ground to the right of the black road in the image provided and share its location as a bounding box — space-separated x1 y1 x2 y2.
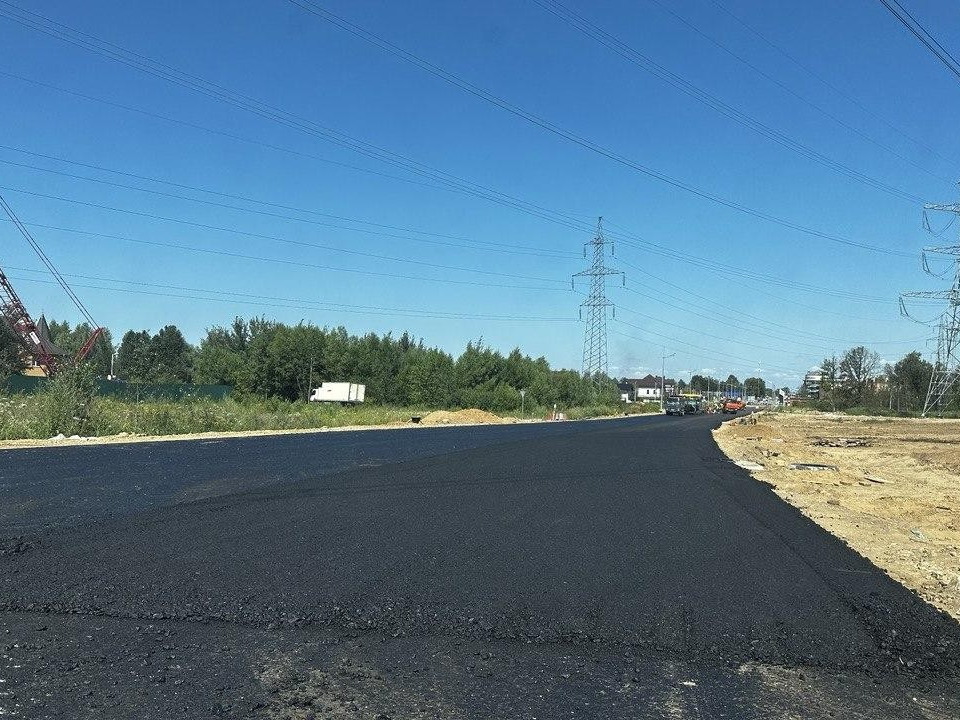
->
714 412 960 620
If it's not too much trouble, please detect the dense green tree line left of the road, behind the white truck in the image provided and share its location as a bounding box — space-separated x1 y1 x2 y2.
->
9 317 618 411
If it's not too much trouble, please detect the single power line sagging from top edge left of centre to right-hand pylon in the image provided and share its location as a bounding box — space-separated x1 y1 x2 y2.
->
289 0 910 257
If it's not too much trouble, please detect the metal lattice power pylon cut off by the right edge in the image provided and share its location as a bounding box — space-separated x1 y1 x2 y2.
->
900 190 960 417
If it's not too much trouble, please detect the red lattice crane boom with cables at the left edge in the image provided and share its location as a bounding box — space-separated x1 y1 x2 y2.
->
0 195 104 377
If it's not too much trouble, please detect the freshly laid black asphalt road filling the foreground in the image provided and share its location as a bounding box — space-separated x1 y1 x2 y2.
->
0 416 960 720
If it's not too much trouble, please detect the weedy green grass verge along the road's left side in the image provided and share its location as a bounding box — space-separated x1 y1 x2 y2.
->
0 392 642 440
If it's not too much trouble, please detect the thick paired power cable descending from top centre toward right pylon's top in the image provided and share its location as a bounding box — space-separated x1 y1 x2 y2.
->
533 0 923 197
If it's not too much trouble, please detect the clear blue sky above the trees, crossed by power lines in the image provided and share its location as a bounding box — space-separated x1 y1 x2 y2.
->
0 0 960 386
